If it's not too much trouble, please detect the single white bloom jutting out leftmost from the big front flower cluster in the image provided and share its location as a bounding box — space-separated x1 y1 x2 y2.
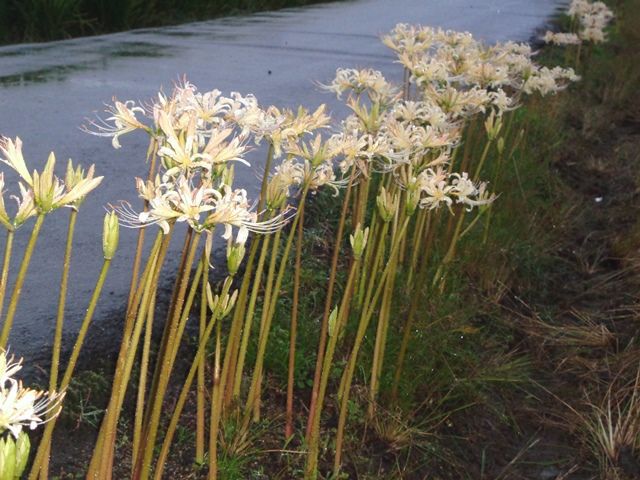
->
82 99 152 148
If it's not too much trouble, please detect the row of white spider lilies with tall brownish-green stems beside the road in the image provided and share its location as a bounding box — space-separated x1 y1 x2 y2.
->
0 5 608 480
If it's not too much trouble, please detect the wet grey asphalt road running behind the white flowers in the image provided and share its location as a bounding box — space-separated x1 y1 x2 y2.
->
0 0 561 364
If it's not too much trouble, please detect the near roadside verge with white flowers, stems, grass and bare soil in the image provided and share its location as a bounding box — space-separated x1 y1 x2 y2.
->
0 0 640 480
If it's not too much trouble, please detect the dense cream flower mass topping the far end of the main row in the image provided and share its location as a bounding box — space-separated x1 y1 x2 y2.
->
383 24 573 101
